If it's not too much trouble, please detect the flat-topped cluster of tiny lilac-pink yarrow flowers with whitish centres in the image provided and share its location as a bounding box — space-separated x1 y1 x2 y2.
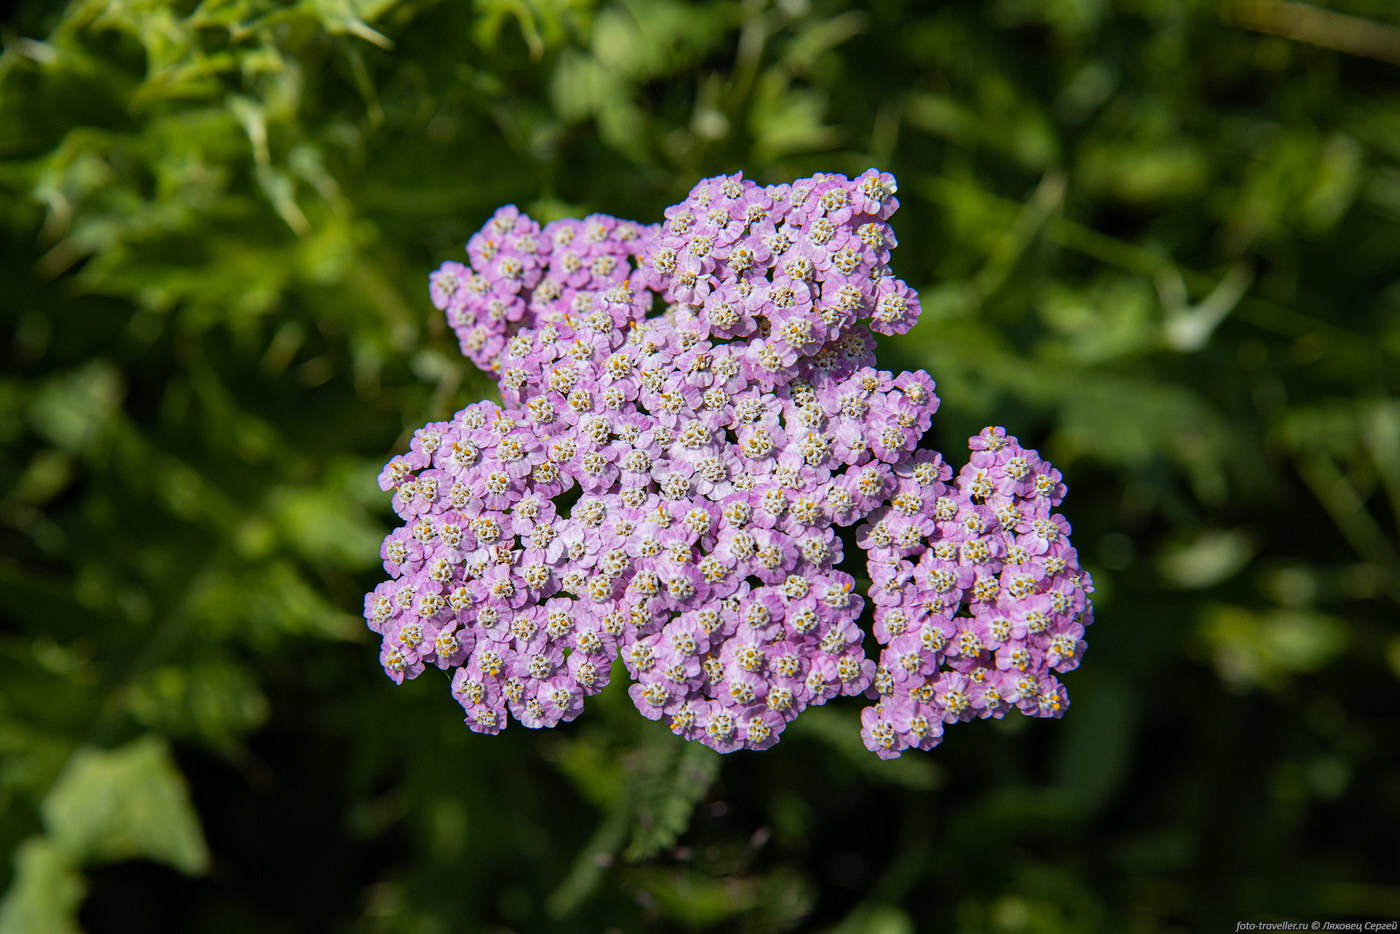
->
365 169 1093 758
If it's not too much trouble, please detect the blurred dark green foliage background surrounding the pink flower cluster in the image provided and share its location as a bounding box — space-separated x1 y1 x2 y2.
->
0 0 1400 934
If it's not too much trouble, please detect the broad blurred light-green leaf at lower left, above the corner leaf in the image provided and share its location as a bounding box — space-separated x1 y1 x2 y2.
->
42 735 209 875
